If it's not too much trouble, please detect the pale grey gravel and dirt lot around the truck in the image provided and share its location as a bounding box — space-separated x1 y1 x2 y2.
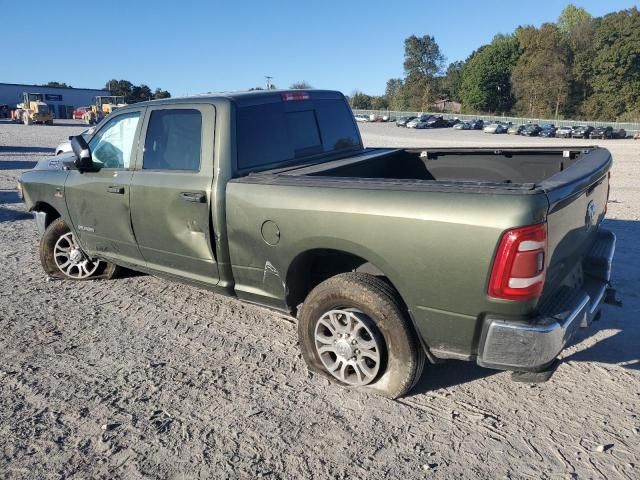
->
0 122 640 479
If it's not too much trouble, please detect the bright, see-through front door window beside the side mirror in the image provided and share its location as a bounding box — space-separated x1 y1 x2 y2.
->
89 112 140 168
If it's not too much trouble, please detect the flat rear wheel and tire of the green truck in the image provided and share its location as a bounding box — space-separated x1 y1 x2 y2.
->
298 272 425 398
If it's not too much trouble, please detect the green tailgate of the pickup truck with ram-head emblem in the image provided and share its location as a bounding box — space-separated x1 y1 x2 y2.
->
540 148 612 299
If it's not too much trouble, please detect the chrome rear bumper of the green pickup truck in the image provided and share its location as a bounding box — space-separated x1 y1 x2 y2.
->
477 230 616 371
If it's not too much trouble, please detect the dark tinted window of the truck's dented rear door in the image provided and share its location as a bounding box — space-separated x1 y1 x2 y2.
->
142 109 202 171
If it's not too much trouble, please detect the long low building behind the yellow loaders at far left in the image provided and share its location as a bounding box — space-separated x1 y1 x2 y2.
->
0 83 111 118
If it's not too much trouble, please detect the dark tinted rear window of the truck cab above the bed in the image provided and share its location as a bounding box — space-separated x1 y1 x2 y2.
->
237 99 360 170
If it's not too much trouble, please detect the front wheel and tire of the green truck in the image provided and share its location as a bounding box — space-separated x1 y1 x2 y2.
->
40 218 119 280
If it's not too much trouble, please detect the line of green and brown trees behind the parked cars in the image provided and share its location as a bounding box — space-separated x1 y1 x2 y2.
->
350 5 640 121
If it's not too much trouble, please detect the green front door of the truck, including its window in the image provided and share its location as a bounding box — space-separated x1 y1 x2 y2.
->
64 109 144 263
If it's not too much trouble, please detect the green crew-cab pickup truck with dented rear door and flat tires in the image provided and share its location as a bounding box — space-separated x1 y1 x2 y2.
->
20 90 615 398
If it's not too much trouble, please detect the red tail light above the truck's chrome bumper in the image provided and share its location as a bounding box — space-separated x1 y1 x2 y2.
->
487 223 547 300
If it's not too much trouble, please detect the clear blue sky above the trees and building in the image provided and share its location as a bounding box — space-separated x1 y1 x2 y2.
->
0 0 640 96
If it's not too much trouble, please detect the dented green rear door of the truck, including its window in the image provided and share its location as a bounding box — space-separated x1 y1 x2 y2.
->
131 103 219 284
